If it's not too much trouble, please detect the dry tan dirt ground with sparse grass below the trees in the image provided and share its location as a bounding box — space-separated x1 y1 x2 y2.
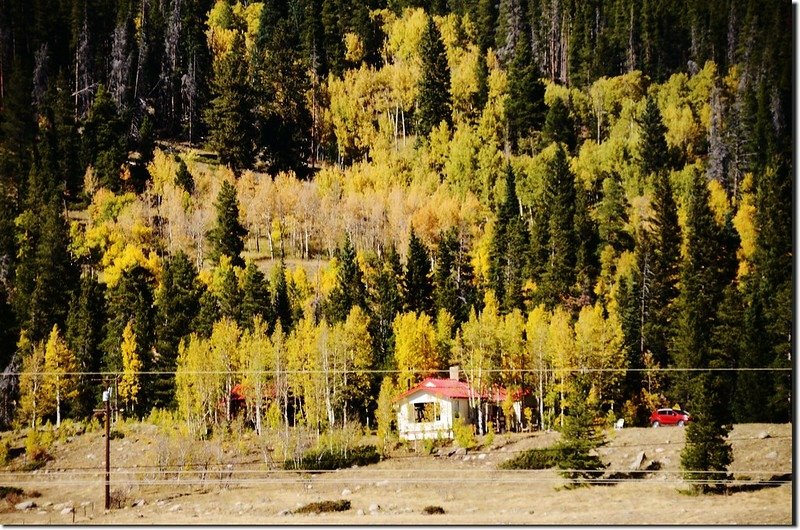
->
0 424 794 525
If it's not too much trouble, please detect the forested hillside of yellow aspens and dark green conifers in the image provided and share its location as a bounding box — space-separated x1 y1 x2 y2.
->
0 0 794 482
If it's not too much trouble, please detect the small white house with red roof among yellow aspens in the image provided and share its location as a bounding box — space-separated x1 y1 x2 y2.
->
395 367 519 440
